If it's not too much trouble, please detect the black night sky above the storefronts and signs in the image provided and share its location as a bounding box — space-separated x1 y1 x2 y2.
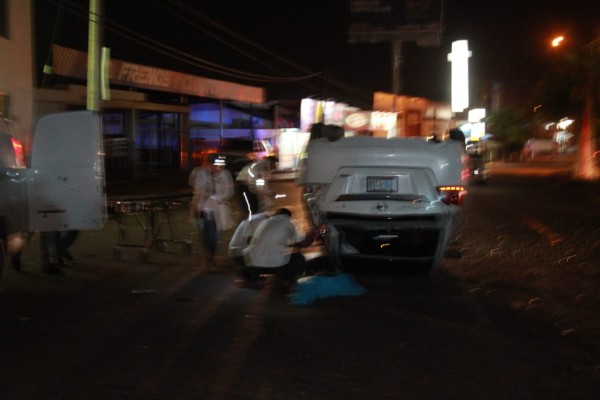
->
34 0 600 108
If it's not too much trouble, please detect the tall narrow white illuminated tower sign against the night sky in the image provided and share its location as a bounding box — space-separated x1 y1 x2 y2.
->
448 40 471 112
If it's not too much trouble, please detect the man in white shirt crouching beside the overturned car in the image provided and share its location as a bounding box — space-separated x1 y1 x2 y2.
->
236 208 316 286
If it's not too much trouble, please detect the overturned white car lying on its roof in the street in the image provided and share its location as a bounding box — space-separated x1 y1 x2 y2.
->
298 128 469 272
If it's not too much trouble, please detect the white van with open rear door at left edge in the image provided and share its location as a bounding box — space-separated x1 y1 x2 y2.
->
0 111 106 277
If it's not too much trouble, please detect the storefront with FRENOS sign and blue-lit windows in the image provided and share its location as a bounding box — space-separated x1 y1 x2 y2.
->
35 46 274 180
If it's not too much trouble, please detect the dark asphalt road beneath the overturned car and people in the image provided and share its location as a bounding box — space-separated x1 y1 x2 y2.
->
0 163 600 399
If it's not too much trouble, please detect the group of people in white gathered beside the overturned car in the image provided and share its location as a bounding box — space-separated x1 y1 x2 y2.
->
189 156 317 286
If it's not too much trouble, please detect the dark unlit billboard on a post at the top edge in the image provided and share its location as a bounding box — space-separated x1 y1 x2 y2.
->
348 0 444 42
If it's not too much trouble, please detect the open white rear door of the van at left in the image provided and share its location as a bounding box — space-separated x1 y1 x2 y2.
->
29 111 106 231
